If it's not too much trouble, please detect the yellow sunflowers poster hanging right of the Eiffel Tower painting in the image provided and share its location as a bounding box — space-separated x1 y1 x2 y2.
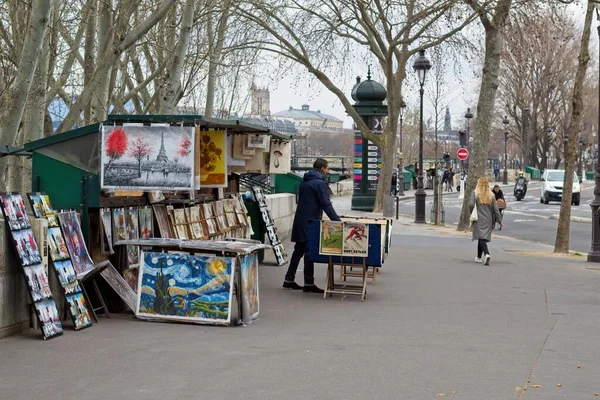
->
196 131 227 188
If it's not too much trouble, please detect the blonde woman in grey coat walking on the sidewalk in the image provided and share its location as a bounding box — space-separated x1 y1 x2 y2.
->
469 176 504 265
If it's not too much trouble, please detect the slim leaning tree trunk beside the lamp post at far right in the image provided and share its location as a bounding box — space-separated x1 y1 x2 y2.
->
554 1 594 253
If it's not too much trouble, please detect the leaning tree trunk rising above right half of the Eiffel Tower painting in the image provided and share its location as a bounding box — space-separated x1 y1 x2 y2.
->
160 0 195 114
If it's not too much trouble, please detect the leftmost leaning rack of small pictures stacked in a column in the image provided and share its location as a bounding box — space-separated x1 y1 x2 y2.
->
0 193 63 339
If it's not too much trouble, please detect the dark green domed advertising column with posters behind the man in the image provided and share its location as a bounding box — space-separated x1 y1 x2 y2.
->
352 68 388 211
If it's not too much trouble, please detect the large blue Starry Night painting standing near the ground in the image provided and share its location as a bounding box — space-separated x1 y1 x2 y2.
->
136 252 235 325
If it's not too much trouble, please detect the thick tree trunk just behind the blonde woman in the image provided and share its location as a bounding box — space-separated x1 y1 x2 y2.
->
457 0 512 231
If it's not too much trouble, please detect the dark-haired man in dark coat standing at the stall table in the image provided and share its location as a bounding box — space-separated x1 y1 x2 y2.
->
283 158 340 293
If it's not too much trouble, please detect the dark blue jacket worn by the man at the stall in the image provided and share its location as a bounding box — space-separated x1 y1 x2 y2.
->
292 168 340 243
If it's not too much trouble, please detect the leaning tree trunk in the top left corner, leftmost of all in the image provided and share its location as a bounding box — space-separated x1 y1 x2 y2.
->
0 0 52 191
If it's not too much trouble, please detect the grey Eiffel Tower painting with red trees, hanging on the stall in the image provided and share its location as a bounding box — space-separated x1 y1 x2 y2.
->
100 125 194 190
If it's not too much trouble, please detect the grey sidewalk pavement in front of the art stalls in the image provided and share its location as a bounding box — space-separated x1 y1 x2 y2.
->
0 203 600 400
